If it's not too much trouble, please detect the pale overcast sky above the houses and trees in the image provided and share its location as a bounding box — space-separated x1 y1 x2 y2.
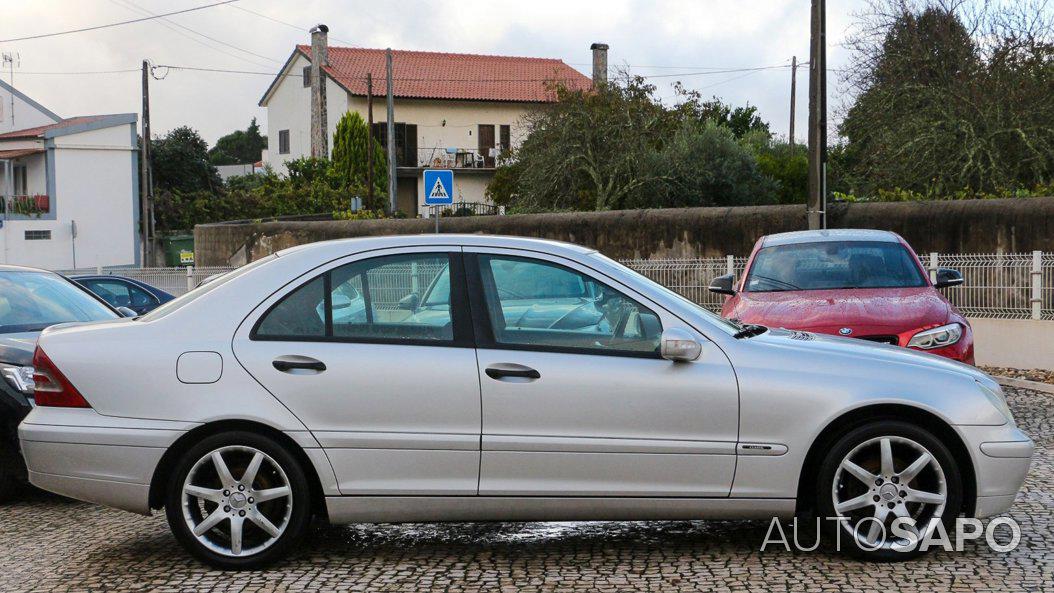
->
0 0 862 144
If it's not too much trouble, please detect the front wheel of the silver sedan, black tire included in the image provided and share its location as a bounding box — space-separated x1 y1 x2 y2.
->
816 419 963 561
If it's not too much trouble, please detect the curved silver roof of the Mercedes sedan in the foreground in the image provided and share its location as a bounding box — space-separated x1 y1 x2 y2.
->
275 234 597 257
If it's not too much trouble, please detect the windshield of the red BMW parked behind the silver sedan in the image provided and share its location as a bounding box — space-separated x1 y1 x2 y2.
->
745 241 926 293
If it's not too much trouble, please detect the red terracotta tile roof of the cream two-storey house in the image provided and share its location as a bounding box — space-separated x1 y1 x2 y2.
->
296 45 591 102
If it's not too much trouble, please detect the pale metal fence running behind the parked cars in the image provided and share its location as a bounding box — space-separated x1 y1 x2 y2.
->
58 252 1054 320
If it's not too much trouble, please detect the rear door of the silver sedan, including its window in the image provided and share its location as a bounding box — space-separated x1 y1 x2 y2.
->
234 248 481 495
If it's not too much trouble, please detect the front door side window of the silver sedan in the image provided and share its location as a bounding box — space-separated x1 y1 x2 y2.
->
477 255 662 355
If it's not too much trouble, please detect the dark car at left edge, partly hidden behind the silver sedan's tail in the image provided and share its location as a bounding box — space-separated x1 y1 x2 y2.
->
0 265 127 500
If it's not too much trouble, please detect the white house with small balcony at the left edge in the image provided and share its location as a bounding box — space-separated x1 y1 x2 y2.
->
0 81 139 270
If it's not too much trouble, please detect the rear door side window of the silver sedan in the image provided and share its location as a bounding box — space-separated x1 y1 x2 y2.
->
253 254 454 342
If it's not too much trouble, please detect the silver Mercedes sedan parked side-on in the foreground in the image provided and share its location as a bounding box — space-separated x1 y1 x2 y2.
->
20 235 1033 569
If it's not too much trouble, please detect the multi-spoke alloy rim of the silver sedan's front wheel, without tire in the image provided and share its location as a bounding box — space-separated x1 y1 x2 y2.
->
831 435 948 550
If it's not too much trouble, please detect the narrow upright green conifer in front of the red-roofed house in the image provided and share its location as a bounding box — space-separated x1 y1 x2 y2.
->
331 112 388 209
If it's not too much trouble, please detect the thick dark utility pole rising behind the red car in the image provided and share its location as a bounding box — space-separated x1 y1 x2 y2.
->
806 0 827 229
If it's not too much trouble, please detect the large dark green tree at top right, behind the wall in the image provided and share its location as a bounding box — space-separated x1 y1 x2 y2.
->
839 0 1054 197
